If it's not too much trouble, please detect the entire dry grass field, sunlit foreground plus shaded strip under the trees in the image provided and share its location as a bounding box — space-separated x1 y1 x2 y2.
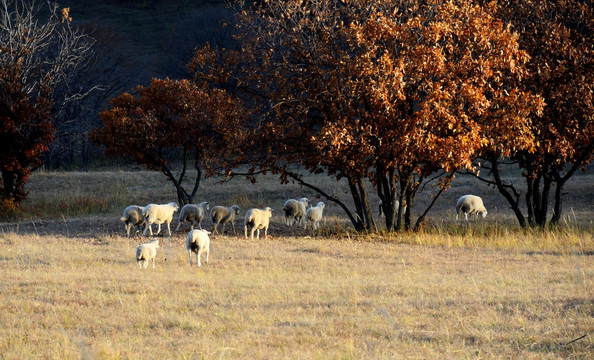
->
0 171 594 359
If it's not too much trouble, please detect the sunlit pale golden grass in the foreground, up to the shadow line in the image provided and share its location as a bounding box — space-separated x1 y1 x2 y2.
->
0 233 594 359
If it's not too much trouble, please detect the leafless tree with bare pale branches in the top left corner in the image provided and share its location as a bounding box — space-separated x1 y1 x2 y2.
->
0 0 101 169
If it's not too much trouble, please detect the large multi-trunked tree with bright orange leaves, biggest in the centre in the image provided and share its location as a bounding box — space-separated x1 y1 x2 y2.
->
192 0 540 230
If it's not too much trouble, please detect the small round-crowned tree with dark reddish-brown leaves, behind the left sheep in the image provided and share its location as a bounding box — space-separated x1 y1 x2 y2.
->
90 79 244 205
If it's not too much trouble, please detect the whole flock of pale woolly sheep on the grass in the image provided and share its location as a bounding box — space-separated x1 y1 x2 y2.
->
120 194 487 268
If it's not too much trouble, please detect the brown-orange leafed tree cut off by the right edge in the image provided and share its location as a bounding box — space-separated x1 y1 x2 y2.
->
470 0 594 227
